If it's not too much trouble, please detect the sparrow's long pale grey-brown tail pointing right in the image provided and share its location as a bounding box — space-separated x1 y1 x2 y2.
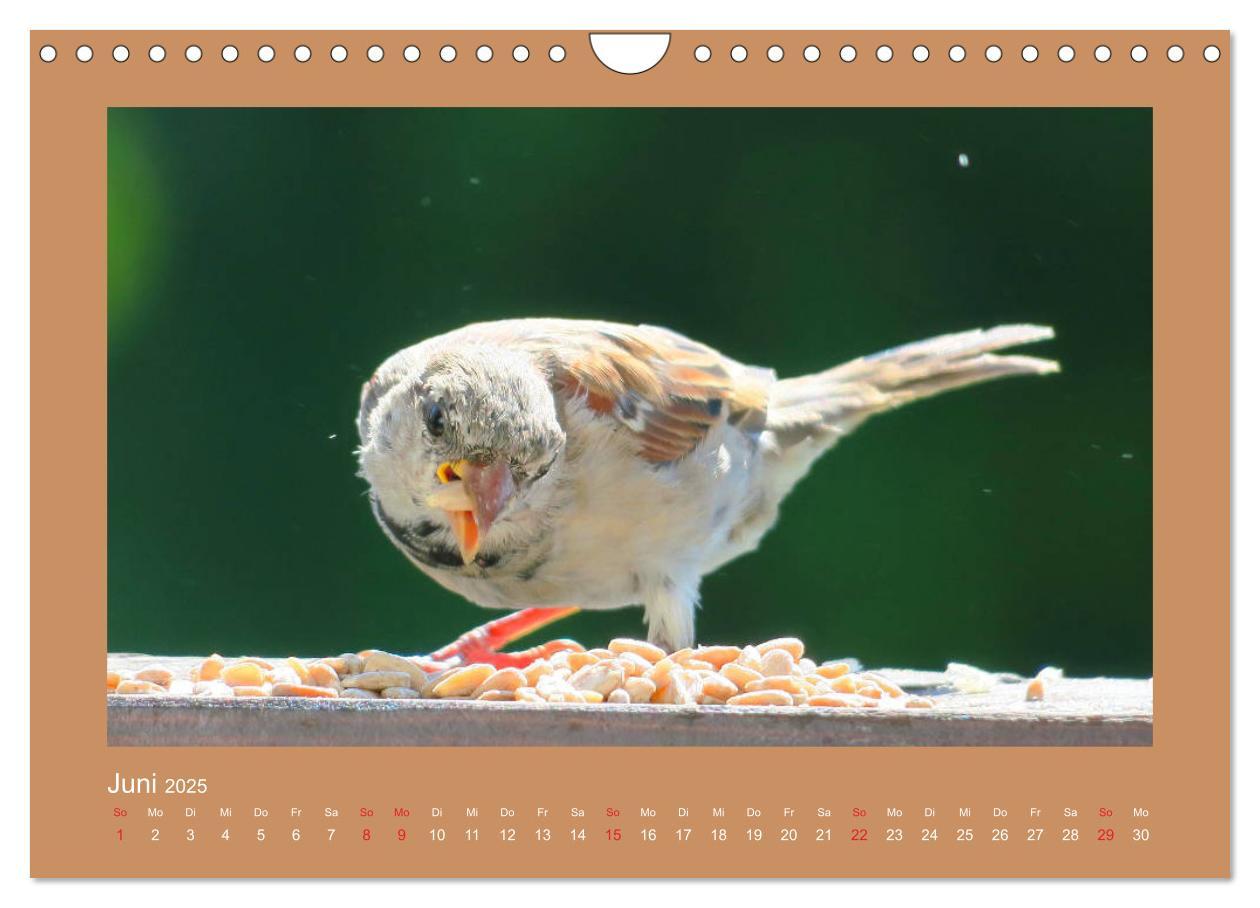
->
766 325 1058 450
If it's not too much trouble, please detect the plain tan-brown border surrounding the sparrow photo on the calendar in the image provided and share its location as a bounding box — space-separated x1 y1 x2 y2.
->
30 30 1231 877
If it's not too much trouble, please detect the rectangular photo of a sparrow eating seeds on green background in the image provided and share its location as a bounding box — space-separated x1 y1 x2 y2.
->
102 106 1155 747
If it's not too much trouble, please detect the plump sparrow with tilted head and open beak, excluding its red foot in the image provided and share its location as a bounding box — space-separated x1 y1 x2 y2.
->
358 319 1058 650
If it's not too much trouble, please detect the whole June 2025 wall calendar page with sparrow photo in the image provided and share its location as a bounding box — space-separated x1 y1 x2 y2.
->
30 30 1231 878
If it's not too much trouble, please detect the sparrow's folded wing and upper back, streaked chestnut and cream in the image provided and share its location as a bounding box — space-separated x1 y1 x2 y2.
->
456 319 774 463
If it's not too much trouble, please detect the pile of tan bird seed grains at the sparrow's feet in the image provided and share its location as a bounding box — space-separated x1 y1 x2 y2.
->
106 637 934 709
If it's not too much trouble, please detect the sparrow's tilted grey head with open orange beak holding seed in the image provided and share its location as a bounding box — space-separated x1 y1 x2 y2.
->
359 345 564 564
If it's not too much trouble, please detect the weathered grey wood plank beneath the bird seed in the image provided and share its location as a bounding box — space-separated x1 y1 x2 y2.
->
107 654 1153 747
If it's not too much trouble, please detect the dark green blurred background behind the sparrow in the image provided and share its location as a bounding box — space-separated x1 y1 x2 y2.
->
108 110 1152 676
